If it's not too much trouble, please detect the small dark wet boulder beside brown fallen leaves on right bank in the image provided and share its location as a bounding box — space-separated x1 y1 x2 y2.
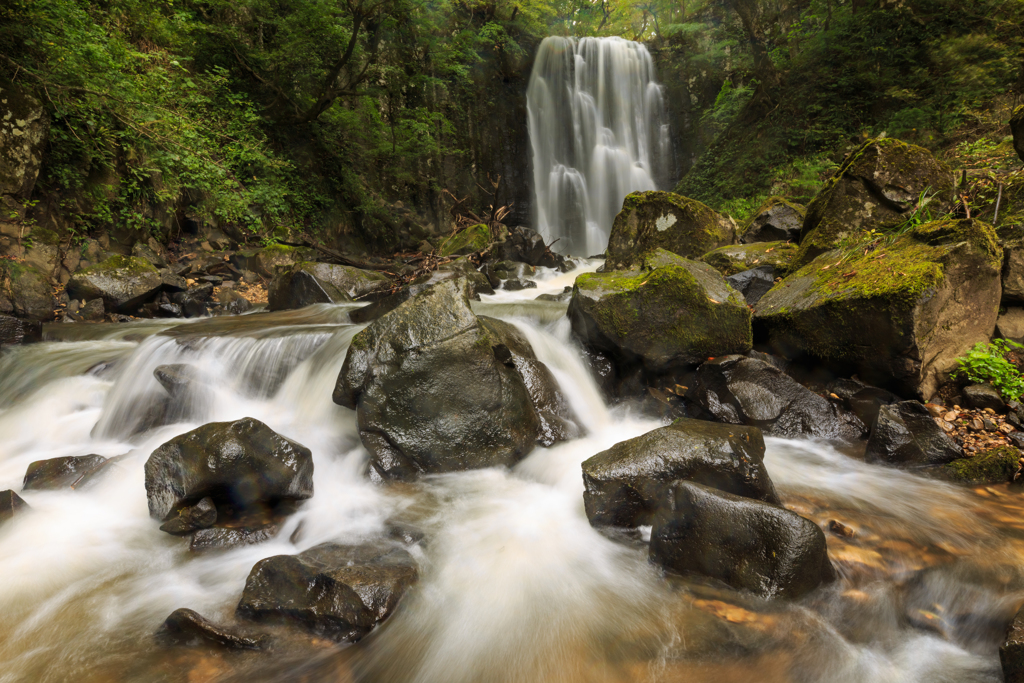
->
864 400 964 465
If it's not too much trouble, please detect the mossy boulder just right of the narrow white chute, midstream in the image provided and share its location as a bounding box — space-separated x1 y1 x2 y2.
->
568 249 752 375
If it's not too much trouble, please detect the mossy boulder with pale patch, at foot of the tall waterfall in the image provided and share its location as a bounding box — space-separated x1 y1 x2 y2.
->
605 191 736 270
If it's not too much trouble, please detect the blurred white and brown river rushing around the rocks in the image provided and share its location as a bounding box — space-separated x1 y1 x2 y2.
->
0 262 1024 683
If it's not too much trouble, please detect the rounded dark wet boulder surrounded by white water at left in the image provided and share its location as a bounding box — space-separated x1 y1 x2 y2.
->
145 418 313 520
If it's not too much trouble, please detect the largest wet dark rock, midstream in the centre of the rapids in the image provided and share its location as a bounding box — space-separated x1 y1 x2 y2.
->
334 279 574 479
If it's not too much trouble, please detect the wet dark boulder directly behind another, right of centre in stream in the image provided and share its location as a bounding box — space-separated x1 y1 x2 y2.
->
583 418 779 527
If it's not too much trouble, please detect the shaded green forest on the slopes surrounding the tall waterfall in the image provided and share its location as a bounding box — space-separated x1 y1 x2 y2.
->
0 0 1024 252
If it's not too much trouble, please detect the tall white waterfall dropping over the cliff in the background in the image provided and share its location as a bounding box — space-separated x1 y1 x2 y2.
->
526 37 671 256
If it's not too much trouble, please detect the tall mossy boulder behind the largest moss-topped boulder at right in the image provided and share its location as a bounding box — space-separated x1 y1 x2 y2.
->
794 138 953 267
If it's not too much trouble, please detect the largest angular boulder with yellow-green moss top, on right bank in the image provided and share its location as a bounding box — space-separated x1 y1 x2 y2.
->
755 220 1002 399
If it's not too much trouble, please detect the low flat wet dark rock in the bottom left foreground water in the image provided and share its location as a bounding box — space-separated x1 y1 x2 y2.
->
238 543 418 641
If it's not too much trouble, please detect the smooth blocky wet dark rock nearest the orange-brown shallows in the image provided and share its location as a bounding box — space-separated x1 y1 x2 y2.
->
650 481 836 598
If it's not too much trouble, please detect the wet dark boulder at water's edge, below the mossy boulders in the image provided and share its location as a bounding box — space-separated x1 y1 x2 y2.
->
686 355 862 438
